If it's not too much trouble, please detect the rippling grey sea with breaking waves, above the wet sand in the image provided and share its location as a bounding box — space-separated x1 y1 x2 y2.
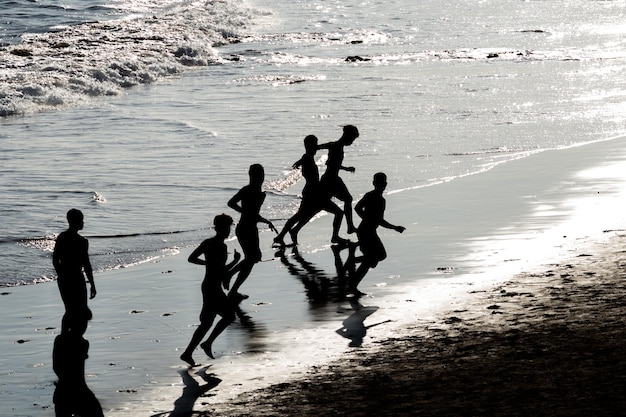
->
0 0 626 286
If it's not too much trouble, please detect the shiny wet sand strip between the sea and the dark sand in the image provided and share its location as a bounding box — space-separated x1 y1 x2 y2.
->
0 136 626 417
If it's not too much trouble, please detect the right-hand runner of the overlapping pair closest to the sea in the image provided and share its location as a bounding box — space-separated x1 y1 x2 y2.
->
319 125 359 243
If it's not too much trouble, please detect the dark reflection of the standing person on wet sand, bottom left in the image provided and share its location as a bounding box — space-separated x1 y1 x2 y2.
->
52 307 104 417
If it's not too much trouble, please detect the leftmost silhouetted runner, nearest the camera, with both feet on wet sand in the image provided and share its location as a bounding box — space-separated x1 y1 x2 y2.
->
180 214 240 366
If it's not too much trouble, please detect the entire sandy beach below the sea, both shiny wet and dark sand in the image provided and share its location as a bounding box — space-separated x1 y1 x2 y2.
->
0 140 626 417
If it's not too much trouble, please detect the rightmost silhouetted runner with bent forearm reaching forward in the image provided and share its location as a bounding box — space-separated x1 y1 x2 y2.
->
348 172 405 296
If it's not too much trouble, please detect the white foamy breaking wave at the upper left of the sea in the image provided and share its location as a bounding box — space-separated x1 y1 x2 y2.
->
0 0 258 116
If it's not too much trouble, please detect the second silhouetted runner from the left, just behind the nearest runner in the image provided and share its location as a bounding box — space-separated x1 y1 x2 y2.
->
225 164 278 301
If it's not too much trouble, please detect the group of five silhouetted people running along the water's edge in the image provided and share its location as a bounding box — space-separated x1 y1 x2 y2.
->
180 125 404 366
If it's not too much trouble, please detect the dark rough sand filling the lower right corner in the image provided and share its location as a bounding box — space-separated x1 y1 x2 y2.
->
207 231 626 416
